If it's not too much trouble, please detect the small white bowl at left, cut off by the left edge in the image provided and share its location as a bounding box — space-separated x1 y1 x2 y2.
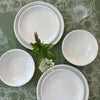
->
0 49 35 87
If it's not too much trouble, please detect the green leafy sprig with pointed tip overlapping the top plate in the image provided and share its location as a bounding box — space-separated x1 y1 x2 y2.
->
30 32 54 63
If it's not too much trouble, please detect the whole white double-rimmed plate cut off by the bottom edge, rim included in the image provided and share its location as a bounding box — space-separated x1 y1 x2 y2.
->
37 65 89 100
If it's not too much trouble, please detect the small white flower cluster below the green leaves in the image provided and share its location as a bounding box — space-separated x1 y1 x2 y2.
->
39 58 54 72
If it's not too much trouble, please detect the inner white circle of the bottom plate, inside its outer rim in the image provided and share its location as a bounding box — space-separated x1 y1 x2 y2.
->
41 69 84 100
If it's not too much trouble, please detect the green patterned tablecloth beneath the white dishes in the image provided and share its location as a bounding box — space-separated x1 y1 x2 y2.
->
0 0 100 100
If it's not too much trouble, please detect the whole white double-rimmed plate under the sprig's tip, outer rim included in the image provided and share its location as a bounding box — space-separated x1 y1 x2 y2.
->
14 2 64 49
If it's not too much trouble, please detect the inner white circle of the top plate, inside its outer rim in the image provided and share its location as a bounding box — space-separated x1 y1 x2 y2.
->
18 5 60 43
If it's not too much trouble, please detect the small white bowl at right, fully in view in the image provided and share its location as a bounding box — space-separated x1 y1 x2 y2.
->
62 30 98 66
